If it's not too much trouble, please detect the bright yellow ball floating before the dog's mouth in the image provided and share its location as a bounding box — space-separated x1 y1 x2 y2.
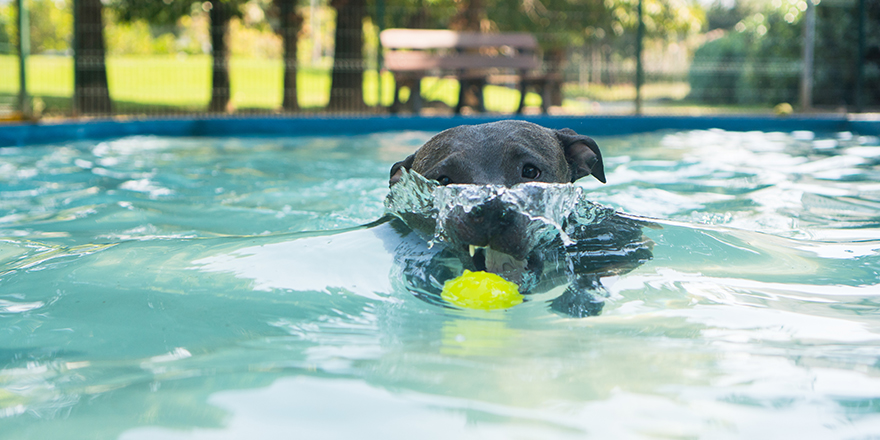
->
440 270 523 310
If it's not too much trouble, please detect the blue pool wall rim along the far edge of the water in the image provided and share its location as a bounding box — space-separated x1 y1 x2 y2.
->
0 115 880 147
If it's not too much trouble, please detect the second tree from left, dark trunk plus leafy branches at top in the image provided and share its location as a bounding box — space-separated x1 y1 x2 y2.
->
111 0 244 112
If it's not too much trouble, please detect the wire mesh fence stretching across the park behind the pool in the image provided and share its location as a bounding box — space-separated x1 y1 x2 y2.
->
0 0 880 119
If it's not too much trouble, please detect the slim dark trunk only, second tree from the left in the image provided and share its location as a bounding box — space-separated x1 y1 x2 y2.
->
208 0 231 112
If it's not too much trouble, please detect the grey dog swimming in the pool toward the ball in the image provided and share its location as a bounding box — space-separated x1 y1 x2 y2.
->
386 120 652 317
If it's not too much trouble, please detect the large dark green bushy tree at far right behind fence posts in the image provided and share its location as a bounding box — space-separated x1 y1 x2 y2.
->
689 0 880 106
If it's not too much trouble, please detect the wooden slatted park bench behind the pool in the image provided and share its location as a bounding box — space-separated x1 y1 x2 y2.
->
379 29 554 114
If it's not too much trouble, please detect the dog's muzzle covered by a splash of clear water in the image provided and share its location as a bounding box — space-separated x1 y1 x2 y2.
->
385 170 612 282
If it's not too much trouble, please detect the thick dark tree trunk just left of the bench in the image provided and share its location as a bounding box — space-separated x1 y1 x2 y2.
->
327 0 367 110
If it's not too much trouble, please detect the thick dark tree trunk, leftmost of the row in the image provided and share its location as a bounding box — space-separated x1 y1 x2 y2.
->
73 0 112 115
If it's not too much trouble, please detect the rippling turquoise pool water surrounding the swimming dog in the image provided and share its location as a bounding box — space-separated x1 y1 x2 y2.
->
0 131 880 440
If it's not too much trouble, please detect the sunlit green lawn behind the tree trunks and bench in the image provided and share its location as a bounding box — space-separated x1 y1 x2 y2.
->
0 55 744 115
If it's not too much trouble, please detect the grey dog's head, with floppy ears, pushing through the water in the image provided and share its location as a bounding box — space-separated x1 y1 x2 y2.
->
390 121 605 281
